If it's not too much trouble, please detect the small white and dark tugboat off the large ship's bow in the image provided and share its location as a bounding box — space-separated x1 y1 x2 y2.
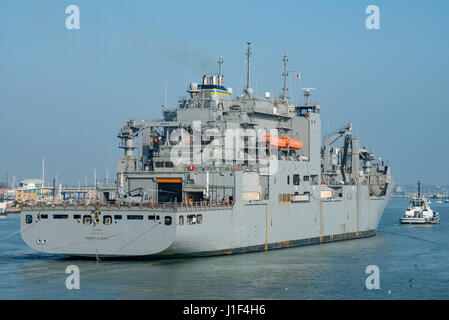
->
399 181 439 224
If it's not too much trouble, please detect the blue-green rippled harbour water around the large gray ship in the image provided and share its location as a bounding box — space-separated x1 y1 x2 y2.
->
0 199 449 300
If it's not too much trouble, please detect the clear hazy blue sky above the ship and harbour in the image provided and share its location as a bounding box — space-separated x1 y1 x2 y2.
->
0 0 449 184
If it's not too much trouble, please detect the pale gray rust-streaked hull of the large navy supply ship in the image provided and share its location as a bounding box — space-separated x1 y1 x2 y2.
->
21 186 392 258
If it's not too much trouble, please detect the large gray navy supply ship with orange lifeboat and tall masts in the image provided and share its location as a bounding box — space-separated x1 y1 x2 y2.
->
21 43 394 258
